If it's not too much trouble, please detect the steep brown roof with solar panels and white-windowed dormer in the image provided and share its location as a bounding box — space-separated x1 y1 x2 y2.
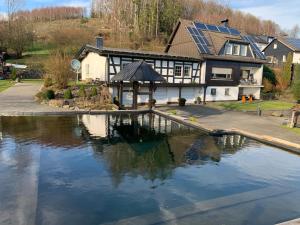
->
165 19 265 63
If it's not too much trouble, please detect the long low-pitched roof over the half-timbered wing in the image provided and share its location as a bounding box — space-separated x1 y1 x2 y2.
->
75 45 200 62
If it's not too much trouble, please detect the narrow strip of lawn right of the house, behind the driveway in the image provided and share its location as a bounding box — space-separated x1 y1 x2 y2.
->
212 101 295 111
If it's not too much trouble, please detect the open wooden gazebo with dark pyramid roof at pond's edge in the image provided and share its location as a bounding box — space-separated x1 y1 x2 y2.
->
112 60 166 109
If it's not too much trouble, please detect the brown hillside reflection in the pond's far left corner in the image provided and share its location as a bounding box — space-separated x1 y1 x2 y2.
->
0 116 83 147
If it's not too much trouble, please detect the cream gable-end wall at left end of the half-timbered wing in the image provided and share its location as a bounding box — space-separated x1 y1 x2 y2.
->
81 52 107 81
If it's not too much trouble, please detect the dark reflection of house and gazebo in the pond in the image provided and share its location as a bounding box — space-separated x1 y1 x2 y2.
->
82 114 245 185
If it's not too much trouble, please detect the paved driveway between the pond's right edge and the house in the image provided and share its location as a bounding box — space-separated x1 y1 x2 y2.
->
157 106 300 152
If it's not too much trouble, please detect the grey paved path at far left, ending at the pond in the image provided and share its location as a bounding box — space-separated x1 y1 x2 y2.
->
0 83 68 116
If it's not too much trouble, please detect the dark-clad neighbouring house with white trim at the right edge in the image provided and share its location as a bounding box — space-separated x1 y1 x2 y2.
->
263 37 300 65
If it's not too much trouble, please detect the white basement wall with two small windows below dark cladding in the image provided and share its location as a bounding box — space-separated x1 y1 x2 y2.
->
206 86 239 102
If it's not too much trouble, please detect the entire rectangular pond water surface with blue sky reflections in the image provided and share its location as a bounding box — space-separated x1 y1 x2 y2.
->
0 114 300 225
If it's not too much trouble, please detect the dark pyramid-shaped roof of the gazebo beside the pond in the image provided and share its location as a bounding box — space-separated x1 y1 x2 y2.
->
112 60 166 82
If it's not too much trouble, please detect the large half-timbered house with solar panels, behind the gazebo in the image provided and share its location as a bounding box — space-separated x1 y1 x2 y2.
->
76 20 266 104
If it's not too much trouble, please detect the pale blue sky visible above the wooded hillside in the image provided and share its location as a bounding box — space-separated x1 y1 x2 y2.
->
0 0 300 29
